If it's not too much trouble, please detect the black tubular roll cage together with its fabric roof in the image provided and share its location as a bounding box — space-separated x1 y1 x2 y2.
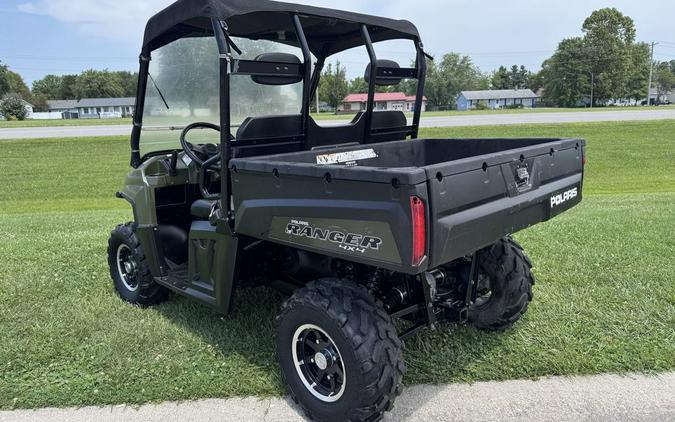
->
131 0 429 224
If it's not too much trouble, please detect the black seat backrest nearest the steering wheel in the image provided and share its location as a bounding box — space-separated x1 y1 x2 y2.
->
232 114 303 158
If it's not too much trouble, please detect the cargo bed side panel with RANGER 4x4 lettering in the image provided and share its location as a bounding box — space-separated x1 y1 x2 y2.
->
233 171 428 274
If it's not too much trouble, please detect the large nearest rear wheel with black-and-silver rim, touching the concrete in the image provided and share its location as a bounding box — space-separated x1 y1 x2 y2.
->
277 279 405 421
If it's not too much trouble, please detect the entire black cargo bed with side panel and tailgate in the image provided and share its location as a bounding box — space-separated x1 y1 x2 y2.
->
230 139 585 274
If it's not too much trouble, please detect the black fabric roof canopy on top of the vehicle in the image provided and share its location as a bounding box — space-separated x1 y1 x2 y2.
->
143 0 419 57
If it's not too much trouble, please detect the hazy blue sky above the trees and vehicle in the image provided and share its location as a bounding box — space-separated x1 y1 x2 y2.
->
0 0 675 85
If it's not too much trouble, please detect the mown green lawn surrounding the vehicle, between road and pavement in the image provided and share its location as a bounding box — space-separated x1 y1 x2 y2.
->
0 121 675 409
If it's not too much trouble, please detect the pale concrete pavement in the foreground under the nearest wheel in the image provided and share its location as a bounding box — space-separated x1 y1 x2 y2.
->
0 373 675 422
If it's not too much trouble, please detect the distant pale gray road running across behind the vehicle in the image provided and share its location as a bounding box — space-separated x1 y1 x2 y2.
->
0 108 675 139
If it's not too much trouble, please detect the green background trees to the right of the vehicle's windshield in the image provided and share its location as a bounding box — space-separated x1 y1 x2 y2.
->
319 8 675 109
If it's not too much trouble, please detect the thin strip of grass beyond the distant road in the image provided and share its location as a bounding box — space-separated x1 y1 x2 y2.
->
0 106 675 129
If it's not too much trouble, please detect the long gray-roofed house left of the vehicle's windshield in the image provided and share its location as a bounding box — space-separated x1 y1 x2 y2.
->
47 97 136 119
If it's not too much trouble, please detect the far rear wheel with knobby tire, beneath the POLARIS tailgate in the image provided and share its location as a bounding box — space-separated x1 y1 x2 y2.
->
469 237 535 330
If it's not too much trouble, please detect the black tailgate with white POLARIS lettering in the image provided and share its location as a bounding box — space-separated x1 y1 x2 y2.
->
425 139 585 267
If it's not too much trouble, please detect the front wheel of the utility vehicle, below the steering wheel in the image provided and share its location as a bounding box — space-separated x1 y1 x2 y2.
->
108 223 168 306
